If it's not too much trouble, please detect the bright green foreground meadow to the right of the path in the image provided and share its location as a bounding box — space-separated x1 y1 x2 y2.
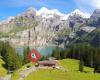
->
25 59 100 80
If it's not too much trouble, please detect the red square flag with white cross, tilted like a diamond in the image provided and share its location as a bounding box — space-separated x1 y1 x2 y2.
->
28 49 42 62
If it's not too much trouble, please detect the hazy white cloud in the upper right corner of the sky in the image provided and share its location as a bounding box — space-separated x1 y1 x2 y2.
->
74 0 100 14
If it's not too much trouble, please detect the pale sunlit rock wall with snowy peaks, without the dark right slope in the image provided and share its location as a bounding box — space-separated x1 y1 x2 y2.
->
0 7 94 47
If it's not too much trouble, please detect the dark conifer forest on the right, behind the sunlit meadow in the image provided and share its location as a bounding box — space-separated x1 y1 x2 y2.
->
52 44 100 73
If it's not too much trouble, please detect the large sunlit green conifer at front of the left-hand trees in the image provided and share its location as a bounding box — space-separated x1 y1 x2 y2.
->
6 47 22 70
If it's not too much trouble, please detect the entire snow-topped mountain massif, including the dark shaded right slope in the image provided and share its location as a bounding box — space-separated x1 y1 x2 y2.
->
0 7 100 48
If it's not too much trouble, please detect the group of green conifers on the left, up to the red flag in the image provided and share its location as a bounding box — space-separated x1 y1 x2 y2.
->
0 42 30 71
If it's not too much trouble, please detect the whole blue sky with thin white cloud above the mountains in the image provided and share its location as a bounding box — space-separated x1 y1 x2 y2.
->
0 0 100 20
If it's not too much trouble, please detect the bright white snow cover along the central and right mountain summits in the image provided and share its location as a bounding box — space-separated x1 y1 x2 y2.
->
36 7 90 20
